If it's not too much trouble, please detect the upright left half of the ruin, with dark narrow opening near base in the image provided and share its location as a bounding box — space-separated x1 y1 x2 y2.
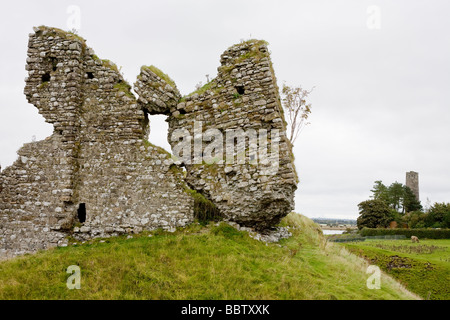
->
0 27 193 255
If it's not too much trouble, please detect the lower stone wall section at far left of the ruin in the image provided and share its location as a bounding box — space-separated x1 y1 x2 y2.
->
0 135 68 258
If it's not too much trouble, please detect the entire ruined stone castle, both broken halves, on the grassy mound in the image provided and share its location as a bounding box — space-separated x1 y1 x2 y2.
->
0 27 297 257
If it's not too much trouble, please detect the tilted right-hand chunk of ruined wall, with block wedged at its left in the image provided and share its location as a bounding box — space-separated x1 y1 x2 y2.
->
135 40 297 229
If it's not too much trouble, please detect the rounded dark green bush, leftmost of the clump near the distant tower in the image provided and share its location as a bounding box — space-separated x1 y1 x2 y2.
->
356 200 392 229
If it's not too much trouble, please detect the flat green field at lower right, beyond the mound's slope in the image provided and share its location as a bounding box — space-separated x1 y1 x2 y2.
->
345 239 450 300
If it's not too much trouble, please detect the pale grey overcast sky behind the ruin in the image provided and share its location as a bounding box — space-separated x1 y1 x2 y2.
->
0 0 450 219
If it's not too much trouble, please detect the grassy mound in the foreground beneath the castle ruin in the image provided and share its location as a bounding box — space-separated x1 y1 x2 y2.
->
0 214 414 299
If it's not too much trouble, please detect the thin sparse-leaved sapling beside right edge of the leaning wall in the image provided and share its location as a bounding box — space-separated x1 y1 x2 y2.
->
281 84 312 144
